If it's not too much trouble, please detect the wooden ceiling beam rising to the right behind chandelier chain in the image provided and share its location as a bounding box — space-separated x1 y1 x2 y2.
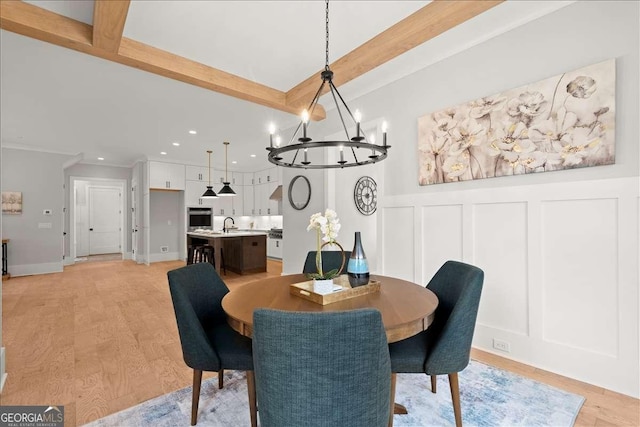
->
286 0 504 104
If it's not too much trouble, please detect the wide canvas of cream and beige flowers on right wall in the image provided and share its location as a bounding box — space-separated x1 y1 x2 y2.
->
418 59 615 185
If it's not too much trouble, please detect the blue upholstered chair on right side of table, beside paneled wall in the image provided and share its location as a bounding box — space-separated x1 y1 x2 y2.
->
389 261 484 427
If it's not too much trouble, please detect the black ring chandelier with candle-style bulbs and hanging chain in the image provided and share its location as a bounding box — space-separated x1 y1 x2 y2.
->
267 0 391 169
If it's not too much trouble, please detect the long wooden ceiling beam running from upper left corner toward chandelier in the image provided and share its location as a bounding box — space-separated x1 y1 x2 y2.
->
0 0 326 120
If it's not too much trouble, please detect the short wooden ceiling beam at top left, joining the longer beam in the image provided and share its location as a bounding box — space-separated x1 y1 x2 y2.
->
93 0 129 53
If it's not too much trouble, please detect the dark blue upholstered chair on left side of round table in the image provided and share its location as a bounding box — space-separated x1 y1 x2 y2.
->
167 262 257 427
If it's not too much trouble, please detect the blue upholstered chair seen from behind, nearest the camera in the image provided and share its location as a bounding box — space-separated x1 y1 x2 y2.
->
253 309 391 427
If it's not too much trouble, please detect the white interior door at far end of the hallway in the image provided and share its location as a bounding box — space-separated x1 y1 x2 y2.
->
89 187 122 255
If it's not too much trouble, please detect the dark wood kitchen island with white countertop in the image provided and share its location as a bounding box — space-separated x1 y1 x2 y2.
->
187 230 267 274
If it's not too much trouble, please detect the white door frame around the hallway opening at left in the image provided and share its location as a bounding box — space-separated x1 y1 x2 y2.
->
67 176 129 265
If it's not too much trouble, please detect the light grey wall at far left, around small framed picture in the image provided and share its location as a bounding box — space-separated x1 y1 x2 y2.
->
2 148 70 276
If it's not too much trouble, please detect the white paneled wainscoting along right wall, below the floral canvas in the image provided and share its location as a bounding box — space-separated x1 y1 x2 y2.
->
378 177 640 397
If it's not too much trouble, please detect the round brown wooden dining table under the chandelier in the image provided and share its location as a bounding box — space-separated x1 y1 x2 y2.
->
222 274 438 343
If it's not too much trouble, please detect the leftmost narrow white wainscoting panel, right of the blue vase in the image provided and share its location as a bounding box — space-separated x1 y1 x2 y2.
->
381 206 416 281
